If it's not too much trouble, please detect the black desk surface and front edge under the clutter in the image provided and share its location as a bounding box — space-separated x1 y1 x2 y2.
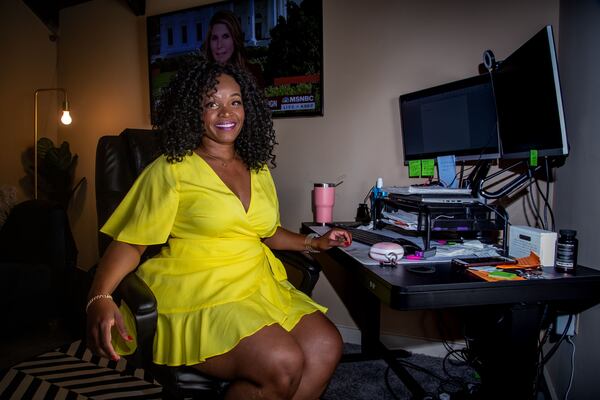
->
303 223 600 311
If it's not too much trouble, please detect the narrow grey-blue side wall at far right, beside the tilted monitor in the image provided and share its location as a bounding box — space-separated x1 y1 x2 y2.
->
548 0 600 399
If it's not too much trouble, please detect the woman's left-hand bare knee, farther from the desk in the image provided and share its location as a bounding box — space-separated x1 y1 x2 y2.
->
263 347 304 399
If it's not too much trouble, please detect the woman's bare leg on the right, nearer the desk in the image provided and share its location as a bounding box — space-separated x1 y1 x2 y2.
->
291 312 342 400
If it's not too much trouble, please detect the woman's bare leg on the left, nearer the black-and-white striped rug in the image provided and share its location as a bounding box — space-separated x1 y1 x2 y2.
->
195 325 304 399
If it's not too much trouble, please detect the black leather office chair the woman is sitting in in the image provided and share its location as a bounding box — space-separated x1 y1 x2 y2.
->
96 129 320 399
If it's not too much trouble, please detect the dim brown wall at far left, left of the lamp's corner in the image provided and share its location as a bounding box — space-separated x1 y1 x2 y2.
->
0 0 58 201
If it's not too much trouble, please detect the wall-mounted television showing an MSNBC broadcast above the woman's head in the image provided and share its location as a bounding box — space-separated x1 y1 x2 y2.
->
146 0 323 123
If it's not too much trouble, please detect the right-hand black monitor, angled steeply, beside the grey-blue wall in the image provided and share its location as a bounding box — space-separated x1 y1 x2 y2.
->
492 25 569 158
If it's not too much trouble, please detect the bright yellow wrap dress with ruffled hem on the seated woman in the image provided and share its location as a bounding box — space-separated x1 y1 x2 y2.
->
101 154 326 365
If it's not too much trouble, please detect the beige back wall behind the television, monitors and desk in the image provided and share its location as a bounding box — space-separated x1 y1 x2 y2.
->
0 0 558 334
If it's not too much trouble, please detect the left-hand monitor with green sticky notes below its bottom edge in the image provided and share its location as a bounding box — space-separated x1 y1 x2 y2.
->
400 74 499 164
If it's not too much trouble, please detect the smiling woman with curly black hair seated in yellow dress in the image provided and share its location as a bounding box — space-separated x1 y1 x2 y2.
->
87 56 352 399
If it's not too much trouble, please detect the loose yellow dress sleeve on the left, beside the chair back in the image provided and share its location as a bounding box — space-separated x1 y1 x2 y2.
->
100 156 179 245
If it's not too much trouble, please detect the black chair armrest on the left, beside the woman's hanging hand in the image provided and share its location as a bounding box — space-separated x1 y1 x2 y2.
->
117 272 158 366
